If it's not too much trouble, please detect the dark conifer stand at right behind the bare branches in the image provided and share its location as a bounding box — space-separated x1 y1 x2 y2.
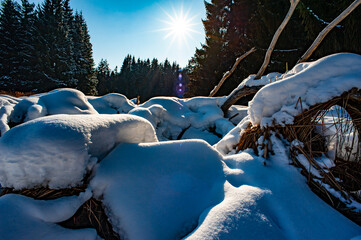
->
187 0 361 96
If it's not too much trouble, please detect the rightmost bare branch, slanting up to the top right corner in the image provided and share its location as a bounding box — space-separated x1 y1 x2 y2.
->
297 0 361 63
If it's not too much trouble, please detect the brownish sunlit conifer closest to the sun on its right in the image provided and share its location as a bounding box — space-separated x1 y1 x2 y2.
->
184 0 247 96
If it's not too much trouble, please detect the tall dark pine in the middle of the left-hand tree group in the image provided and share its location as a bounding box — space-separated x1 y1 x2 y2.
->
36 0 77 91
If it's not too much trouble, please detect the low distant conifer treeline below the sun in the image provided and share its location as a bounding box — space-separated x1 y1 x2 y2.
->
96 55 189 101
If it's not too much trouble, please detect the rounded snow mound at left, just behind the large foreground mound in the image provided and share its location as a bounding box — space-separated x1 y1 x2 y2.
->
11 88 98 123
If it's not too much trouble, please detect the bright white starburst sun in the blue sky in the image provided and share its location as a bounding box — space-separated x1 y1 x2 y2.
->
160 6 198 46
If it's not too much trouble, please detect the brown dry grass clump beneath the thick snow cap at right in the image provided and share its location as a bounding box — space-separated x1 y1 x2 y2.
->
237 89 361 226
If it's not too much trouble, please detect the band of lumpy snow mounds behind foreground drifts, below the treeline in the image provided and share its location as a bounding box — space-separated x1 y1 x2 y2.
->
0 89 236 144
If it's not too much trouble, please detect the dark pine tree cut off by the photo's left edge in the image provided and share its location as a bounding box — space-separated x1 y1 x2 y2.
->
0 0 21 90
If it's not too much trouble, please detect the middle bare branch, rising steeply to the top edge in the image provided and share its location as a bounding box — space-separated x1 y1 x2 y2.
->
255 0 300 79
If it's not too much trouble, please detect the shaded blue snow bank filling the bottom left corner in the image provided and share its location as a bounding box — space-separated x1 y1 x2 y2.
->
0 192 100 240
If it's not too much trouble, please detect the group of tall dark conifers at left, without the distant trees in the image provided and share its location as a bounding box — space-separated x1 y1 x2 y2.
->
0 0 97 94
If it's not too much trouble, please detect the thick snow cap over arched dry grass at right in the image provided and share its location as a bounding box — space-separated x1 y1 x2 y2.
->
249 53 361 126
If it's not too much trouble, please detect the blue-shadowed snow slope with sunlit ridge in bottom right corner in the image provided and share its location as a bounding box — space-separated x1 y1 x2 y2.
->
208 135 361 240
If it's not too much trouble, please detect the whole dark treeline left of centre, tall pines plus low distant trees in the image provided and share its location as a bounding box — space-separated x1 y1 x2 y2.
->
0 0 188 101
